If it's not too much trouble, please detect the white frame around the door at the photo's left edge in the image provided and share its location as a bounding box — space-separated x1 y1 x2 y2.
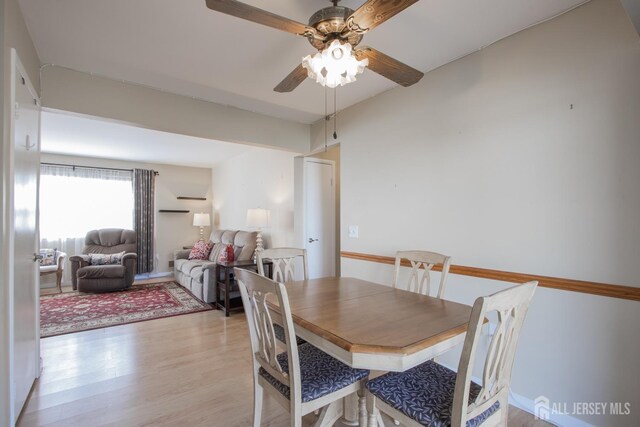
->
0 48 40 426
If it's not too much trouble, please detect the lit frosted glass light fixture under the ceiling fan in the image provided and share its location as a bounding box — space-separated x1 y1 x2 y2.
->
302 40 369 88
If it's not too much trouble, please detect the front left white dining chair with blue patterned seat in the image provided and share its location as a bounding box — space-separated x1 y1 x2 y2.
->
234 268 369 427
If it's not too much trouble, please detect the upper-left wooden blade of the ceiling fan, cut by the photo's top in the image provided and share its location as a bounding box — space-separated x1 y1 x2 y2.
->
206 0 317 37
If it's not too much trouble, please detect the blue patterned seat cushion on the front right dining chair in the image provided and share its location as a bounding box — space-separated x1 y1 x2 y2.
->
367 361 500 427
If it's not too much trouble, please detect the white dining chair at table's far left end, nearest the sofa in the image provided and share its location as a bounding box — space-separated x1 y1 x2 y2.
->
257 248 309 344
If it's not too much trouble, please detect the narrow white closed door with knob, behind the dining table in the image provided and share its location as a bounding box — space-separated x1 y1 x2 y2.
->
304 159 336 279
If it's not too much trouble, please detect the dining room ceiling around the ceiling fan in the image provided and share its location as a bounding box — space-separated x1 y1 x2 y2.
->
19 0 584 123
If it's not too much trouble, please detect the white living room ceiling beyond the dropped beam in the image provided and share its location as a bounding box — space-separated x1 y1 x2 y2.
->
41 111 255 167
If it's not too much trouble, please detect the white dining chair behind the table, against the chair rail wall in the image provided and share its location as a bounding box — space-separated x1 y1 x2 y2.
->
393 251 451 298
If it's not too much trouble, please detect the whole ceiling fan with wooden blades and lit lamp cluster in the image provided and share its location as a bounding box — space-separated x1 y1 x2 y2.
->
206 0 424 92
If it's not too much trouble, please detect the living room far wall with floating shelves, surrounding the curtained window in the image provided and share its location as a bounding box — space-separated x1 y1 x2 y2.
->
41 154 211 280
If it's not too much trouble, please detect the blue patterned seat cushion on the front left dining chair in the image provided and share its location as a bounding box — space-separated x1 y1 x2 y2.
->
259 343 369 402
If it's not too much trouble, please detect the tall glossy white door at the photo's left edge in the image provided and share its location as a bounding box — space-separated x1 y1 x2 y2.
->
12 51 40 419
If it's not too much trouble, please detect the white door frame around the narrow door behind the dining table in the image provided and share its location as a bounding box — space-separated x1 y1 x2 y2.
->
293 156 339 274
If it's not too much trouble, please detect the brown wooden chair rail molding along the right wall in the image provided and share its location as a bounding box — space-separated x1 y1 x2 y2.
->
340 252 640 301
